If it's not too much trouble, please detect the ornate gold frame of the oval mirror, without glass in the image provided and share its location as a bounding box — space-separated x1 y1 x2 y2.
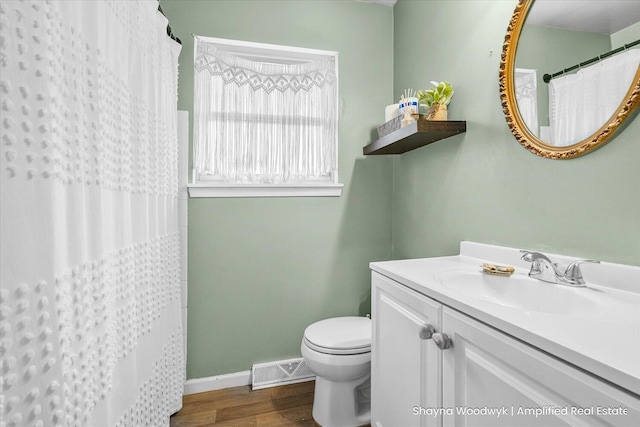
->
499 0 640 159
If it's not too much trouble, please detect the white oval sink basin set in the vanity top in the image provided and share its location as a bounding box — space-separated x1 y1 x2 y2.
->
437 270 601 315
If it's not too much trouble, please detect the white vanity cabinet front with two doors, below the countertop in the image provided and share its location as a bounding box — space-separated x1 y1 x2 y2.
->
371 272 640 427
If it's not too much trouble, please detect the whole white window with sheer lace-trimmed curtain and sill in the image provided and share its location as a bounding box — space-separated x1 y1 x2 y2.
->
189 36 342 197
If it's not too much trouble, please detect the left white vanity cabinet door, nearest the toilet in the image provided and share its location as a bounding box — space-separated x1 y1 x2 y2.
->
371 272 442 427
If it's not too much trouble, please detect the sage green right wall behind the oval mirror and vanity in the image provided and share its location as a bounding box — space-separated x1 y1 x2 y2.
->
393 0 640 265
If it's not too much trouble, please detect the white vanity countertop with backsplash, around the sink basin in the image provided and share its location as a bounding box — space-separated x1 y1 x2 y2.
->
370 242 640 395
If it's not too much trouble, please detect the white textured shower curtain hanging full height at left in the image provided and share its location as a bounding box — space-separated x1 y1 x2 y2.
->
0 0 185 427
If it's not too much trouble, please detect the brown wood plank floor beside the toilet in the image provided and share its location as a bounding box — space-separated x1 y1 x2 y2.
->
171 381 319 427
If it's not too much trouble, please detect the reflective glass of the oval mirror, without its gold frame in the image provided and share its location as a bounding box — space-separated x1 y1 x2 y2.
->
514 0 640 147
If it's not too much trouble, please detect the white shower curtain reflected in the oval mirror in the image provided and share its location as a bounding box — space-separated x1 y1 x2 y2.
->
549 49 640 145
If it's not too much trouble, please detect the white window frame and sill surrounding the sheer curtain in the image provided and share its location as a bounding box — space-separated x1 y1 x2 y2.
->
188 36 344 197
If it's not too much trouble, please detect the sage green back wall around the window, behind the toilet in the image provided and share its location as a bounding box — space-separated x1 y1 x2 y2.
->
162 0 393 378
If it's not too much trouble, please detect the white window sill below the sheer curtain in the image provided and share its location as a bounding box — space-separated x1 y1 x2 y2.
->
187 183 344 197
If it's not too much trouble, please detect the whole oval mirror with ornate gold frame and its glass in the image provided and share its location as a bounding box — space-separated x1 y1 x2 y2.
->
499 0 640 159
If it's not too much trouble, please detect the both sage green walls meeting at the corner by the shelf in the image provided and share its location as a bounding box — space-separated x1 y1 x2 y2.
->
162 0 640 378
